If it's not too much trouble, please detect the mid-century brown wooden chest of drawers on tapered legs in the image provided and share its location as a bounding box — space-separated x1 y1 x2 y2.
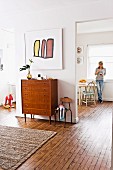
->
21 79 58 123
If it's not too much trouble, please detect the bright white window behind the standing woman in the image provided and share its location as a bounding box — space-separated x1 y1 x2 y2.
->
87 44 113 80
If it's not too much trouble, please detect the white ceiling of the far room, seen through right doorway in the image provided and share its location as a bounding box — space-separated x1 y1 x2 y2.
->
77 19 113 34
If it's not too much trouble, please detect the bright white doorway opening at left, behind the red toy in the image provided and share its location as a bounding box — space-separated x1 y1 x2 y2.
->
0 28 16 107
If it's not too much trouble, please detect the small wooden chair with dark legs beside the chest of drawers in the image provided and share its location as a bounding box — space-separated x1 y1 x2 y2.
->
54 97 72 127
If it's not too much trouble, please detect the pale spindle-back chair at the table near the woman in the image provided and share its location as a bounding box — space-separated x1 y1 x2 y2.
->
81 81 96 106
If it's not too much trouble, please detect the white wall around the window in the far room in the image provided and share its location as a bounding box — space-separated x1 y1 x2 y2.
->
77 32 113 101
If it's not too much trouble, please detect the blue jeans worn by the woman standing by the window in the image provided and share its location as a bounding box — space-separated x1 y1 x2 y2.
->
96 80 104 100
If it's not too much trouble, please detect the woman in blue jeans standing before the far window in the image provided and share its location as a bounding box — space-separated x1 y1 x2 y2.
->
95 61 106 103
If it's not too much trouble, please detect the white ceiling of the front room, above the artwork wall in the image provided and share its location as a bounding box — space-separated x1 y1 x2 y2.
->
0 0 106 15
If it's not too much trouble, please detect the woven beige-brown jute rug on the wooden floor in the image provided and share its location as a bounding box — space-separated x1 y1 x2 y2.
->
0 126 56 170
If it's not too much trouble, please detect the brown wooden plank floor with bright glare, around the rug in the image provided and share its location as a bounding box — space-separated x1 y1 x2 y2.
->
0 102 113 170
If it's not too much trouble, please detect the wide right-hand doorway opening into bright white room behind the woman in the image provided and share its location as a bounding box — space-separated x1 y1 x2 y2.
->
76 19 113 117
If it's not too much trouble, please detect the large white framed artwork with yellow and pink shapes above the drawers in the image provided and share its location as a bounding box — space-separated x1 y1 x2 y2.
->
25 29 62 70
